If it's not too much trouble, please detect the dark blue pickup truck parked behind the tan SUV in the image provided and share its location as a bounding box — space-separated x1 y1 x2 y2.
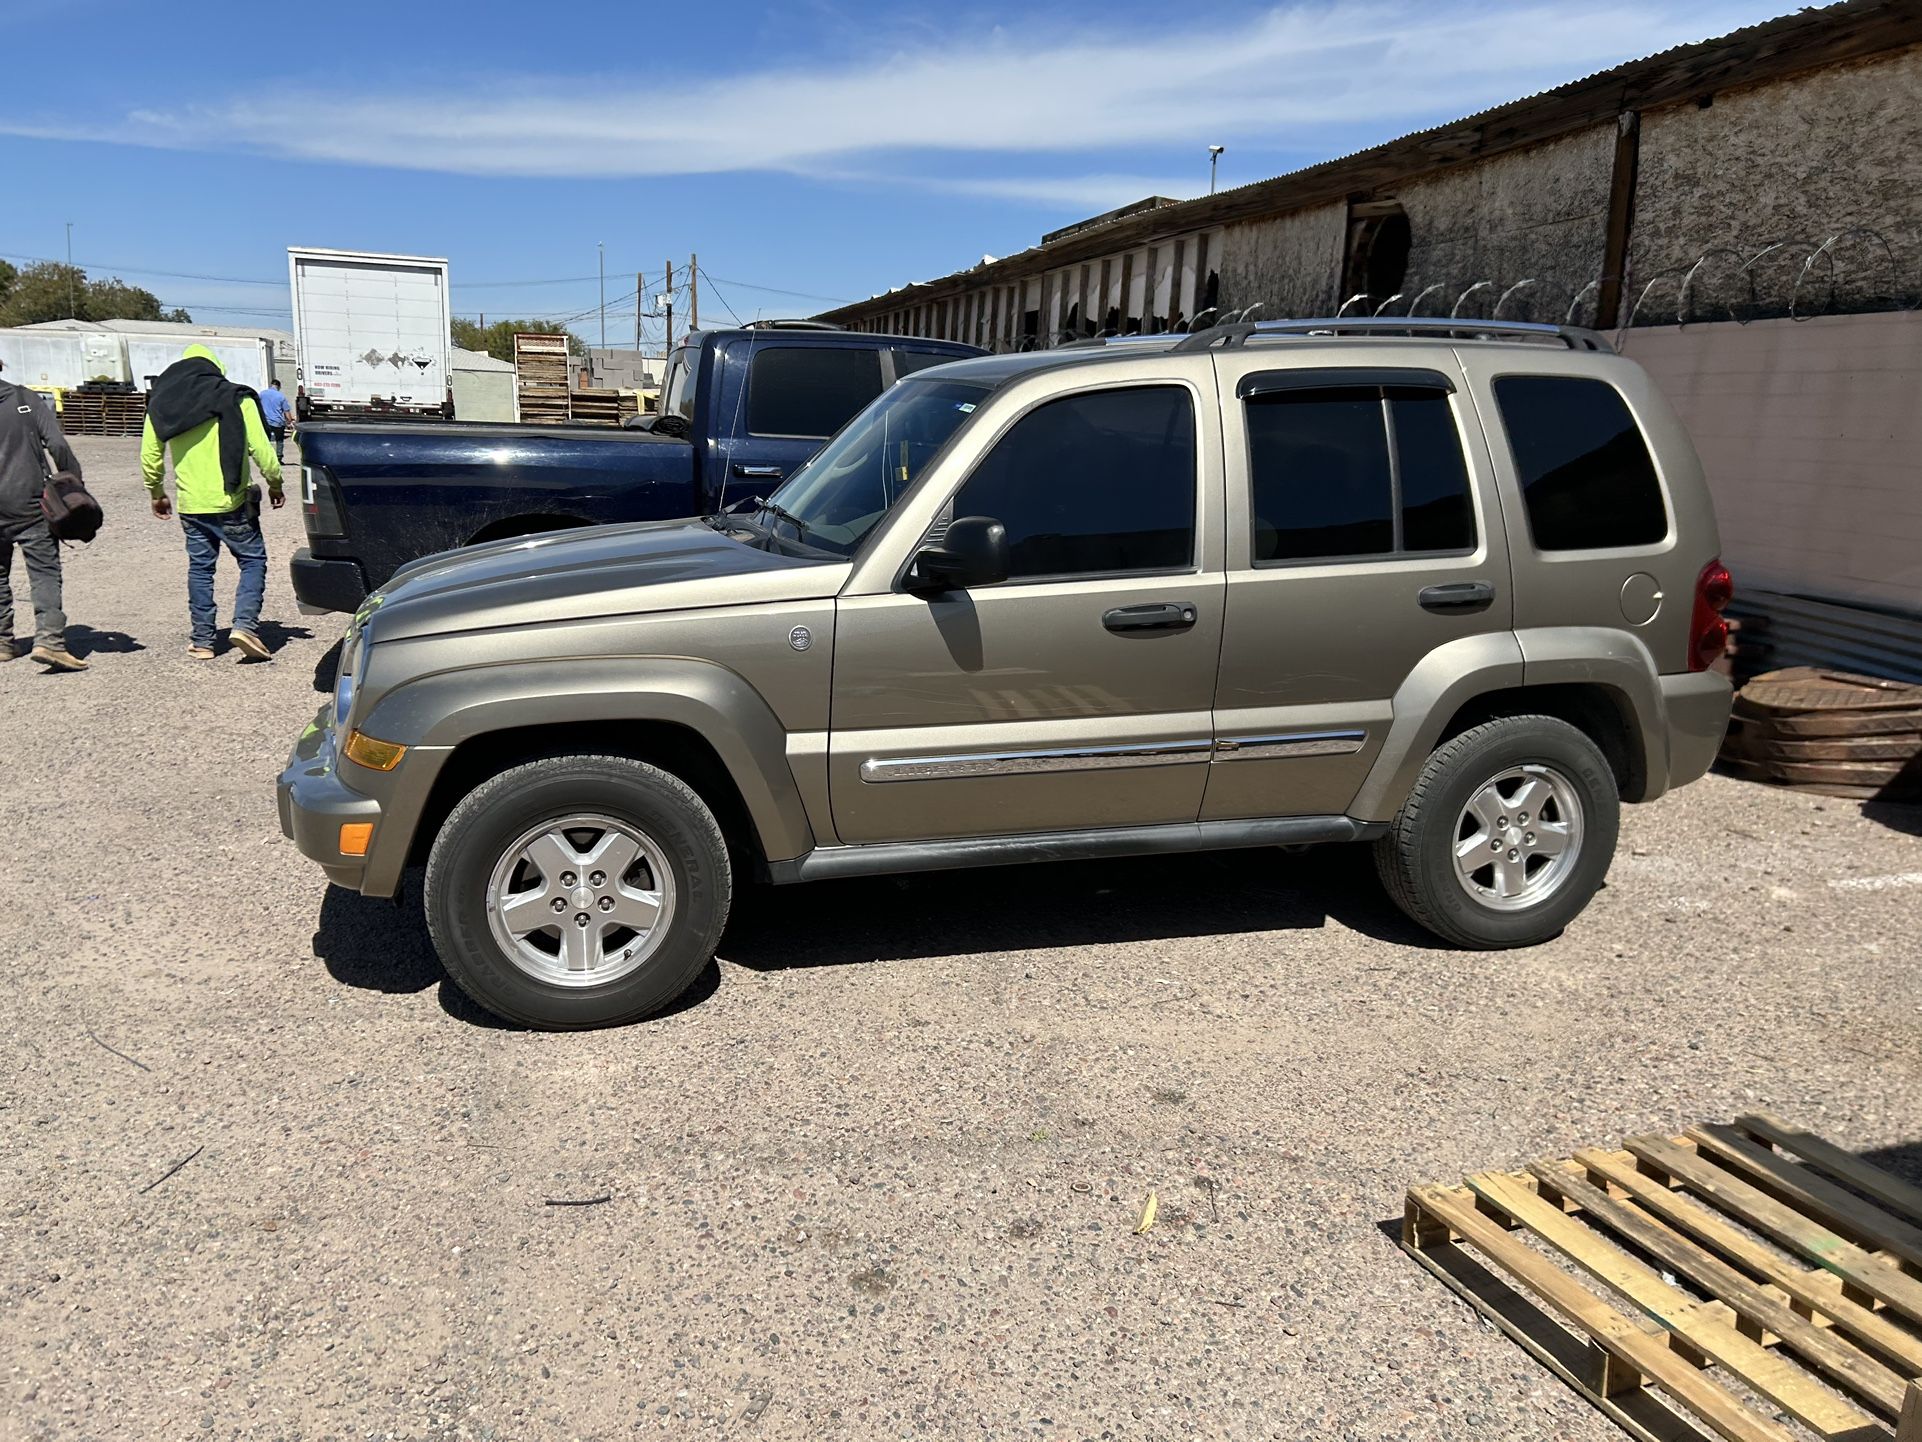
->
292 325 982 611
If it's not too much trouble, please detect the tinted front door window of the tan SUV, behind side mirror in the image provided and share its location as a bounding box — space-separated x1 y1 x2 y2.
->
953 386 1195 577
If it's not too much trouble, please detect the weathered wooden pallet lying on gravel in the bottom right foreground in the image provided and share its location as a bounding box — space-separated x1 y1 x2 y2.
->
1401 1115 1922 1442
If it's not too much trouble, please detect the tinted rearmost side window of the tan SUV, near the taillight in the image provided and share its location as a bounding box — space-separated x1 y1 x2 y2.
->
1495 375 1668 550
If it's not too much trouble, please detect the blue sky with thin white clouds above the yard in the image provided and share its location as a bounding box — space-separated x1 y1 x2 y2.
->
0 0 1789 344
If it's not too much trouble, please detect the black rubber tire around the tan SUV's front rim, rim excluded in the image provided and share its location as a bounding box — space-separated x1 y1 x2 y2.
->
427 761 730 1031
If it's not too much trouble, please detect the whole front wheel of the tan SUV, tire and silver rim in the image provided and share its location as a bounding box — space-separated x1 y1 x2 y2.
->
425 756 734 1031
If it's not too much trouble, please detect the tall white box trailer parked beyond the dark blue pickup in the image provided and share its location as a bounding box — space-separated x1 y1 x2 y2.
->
286 246 454 419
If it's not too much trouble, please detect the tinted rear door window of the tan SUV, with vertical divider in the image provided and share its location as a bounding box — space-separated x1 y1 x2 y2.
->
1245 386 1474 561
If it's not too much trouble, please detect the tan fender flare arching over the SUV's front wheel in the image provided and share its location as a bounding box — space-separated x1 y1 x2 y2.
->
363 656 815 861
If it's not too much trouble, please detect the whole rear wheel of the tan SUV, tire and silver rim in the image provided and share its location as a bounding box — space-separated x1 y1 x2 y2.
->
1374 715 1622 950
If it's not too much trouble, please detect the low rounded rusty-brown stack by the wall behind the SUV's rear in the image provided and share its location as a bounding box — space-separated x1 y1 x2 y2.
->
1722 665 1922 802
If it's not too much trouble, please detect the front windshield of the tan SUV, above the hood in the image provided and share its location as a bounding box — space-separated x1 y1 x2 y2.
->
763 381 992 556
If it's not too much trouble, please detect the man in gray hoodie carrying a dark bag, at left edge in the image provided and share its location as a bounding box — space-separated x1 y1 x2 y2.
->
0 361 86 671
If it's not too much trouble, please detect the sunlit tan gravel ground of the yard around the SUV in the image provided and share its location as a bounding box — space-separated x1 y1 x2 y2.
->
11 440 1922 1442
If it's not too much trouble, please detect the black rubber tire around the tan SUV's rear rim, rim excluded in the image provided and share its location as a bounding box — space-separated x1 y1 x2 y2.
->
1415 721 1622 948
